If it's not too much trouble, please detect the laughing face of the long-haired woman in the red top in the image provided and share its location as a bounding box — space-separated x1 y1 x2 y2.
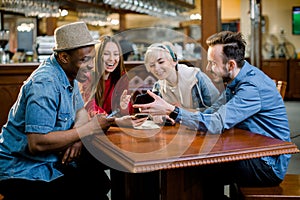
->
102 42 120 73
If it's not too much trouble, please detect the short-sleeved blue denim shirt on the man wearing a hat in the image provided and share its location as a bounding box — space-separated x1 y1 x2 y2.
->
0 55 84 182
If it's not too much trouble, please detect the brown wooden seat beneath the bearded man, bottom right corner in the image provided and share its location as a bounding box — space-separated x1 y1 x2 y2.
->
239 174 300 200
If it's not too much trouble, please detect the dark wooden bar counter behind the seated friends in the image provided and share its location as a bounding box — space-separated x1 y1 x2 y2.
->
0 60 200 128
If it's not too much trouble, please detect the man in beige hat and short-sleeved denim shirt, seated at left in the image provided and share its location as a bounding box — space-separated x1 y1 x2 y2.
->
0 22 114 200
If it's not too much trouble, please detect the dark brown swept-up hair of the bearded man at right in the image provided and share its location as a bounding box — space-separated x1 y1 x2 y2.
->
206 31 246 68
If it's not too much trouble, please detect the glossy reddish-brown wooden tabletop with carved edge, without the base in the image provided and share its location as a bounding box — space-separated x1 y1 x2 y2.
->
92 124 299 173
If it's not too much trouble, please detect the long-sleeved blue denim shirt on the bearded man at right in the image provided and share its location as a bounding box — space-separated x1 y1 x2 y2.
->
176 61 291 179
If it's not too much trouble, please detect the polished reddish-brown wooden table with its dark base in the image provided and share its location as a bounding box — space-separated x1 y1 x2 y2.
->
90 125 299 200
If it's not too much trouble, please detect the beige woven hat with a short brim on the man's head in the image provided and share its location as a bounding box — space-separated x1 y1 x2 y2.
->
53 22 99 51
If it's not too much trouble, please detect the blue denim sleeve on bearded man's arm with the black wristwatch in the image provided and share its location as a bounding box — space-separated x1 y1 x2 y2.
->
176 83 261 134
